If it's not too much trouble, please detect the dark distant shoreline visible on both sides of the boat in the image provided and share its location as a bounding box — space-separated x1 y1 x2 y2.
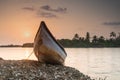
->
0 32 120 48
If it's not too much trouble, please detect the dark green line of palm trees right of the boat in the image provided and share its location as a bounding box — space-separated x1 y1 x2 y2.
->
57 32 120 47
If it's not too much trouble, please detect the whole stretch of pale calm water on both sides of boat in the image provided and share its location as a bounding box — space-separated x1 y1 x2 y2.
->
0 48 120 80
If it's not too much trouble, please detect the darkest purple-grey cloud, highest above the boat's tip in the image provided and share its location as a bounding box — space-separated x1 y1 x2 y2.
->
40 5 67 13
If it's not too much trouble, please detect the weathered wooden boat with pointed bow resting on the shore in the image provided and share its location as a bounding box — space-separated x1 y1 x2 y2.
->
34 21 67 65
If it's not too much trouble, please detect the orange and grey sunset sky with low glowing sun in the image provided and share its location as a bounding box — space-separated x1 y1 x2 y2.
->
0 0 120 45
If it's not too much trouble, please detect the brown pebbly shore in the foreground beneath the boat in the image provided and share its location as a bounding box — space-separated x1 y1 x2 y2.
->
0 58 92 80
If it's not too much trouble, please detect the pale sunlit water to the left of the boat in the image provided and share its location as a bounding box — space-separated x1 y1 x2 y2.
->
0 48 37 60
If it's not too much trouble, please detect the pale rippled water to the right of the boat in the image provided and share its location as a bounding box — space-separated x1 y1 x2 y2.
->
66 48 120 80
